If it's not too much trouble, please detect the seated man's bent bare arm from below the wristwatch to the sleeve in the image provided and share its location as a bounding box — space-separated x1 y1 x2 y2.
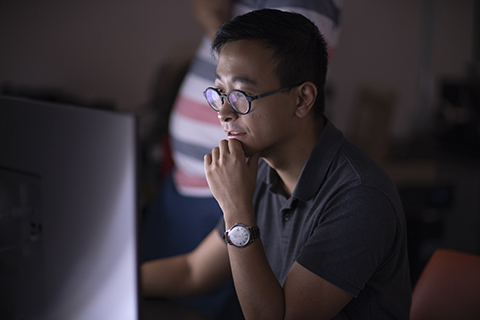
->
229 241 352 319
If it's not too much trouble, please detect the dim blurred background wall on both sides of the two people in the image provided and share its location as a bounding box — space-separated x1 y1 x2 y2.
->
0 0 474 138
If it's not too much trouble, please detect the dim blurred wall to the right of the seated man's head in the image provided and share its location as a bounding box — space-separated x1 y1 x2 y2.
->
329 0 474 138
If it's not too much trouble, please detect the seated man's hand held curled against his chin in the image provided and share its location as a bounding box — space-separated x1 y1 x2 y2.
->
205 139 258 224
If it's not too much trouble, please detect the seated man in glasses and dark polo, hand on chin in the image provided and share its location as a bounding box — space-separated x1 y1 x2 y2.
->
142 10 410 319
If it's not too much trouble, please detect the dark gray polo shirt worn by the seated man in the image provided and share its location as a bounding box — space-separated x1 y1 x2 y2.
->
218 120 411 319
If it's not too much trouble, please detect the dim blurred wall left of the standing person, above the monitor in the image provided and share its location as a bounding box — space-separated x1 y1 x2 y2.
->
0 0 201 109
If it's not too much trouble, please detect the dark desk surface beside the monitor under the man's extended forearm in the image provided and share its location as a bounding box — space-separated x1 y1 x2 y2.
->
140 298 211 320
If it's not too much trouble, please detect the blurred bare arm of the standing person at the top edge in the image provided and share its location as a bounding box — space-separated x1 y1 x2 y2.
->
192 0 232 39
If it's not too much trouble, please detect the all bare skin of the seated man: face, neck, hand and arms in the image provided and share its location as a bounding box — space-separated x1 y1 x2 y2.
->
142 41 352 319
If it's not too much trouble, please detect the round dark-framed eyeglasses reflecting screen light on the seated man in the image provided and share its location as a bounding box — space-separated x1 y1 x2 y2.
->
203 84 300 114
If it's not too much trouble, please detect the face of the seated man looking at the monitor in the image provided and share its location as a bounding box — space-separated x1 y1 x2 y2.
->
215 41 296 158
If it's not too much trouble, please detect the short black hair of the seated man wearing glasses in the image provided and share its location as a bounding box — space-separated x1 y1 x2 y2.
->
212 9 328 115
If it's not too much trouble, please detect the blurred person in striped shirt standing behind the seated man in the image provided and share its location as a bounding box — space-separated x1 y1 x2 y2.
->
142 0 342 319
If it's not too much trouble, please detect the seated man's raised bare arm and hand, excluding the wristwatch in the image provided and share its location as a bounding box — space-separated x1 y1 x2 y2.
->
205 139 352 320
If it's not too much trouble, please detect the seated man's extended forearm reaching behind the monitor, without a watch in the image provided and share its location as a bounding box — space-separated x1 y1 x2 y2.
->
141 230 231 298
